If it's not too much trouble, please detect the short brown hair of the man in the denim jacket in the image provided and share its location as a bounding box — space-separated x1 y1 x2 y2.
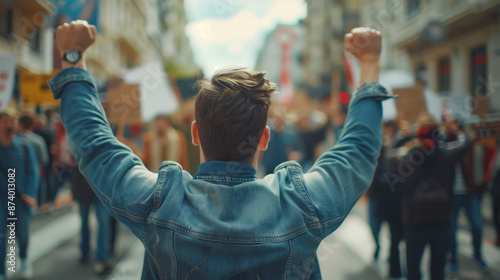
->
195 68 278 163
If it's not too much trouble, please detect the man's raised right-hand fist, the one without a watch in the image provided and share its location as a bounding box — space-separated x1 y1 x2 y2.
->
344 27 382 62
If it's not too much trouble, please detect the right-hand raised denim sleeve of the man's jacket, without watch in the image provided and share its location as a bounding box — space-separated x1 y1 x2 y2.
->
304 83 391 236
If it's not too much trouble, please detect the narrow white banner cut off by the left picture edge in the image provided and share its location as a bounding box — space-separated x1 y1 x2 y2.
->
0 54 16 112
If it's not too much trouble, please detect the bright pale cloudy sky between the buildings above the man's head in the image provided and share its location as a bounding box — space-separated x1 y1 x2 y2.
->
184 0 307 75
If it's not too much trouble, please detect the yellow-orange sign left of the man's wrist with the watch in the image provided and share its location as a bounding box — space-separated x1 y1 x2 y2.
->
18 68 60 105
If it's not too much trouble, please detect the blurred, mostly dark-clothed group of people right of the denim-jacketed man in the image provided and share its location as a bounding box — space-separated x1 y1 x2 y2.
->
368 110 500 279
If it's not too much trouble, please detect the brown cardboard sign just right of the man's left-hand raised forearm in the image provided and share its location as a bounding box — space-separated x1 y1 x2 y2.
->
103 84 141 124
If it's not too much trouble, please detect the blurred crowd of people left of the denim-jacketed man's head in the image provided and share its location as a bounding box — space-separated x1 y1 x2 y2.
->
0 106 198 279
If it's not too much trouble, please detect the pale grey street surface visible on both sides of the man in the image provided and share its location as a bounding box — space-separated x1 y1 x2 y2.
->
4 200 500 280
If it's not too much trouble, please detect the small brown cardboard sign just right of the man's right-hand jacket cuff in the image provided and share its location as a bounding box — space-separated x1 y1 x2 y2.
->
393 85 427 123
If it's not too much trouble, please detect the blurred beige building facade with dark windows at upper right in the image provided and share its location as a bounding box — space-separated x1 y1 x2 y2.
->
361 0 500 113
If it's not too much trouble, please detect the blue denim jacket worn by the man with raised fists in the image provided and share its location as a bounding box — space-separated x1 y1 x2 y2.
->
50 68 388 280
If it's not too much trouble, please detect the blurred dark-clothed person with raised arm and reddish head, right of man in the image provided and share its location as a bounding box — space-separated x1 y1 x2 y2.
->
398 112 467 280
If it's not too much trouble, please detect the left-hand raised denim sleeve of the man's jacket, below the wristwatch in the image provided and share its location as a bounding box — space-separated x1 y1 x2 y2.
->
49 68 157 238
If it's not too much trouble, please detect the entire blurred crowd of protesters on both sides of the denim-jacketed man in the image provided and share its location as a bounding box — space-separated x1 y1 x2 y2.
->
0 97 500 279
